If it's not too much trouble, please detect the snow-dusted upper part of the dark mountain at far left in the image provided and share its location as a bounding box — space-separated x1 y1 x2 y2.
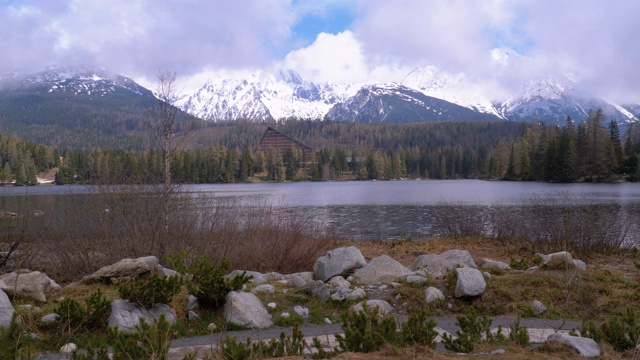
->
0 66 153 98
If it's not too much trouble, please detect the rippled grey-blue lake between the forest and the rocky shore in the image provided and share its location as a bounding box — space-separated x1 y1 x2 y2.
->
0 180 640 244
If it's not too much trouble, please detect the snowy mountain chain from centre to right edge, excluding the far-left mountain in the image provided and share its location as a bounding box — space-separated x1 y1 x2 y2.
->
176 67 640 124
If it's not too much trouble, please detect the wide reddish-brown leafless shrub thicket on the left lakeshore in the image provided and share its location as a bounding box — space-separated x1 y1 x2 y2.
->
28 185 330 281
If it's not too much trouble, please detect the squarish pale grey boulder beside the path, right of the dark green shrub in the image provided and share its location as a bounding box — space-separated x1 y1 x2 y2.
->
224 291 273 329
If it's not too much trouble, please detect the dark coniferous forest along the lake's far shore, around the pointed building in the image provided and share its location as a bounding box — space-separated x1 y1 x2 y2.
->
0 109 640 185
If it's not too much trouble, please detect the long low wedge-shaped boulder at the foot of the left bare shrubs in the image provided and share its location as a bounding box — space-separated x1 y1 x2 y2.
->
80 256 158 284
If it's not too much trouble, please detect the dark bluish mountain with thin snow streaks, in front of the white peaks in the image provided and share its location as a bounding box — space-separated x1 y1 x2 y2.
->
325 83 499 124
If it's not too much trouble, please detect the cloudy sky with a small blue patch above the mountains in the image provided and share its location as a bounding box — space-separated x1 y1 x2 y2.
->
0 0 640 103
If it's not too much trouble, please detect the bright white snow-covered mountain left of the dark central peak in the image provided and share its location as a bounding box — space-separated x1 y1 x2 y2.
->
175 70 357 121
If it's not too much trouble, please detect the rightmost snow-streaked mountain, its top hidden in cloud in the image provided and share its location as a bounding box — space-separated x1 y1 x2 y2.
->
499 76 635 124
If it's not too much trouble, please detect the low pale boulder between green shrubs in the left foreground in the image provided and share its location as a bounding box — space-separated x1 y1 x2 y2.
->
108 299 177 333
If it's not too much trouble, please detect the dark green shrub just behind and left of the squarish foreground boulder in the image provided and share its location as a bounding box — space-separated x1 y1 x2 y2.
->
167 251 252 308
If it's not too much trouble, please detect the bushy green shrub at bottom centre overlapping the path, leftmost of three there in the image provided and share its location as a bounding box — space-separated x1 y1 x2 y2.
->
336 302 397 353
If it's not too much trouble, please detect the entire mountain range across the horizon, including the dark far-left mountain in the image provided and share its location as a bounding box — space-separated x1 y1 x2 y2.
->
0 67 640 148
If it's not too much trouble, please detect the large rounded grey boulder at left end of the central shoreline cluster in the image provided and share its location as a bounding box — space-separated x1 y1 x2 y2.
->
313 246 367 281
